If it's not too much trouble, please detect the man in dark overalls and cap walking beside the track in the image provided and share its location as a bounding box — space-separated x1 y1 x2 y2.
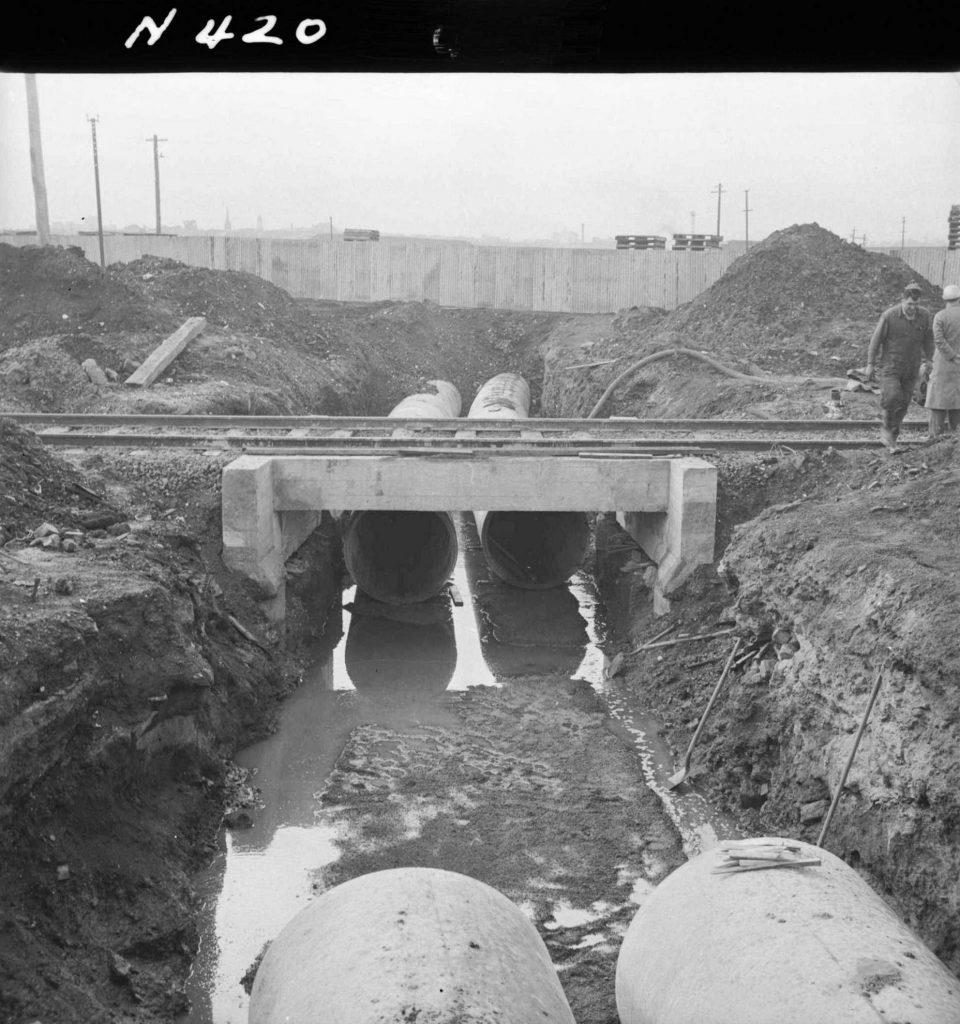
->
867 282 933 452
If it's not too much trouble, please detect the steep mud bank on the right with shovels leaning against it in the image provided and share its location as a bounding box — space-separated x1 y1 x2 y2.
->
598 441 960 972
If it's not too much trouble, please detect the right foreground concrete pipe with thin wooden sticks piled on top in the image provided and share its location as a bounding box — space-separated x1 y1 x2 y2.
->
616 839 960 1024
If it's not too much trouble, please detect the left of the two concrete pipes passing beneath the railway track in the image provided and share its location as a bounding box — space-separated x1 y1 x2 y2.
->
342 381 461 604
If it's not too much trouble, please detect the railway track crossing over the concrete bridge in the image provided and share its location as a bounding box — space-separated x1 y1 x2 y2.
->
3 413 926 457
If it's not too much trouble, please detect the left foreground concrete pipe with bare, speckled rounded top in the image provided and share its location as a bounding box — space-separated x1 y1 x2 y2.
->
248 867 574 1024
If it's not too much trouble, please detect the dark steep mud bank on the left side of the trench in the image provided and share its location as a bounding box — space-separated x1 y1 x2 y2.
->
0 432 339 1024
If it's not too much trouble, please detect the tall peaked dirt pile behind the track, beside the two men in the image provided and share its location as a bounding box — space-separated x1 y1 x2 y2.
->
544 224 943 418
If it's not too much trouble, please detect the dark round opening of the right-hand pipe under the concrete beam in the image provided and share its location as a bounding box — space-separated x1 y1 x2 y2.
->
476 512 590 590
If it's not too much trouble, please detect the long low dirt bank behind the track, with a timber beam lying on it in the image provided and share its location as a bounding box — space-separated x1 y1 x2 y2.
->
0 246 569 416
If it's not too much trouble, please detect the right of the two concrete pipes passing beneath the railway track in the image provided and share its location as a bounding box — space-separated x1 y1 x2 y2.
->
467 374 590 590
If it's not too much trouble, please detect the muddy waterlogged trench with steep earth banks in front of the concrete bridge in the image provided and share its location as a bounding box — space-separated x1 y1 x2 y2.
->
0 409 958 1024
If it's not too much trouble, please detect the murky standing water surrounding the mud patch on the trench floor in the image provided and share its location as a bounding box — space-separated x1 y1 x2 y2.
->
184 516 733 1024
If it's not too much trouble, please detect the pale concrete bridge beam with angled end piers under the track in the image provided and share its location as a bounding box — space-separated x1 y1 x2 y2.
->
223 452 716 620
